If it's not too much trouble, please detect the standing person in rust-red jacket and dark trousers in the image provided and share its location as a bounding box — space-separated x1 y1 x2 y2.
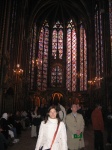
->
91 104 104 150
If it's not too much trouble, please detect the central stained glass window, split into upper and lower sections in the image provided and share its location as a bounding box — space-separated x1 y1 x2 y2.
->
51 21 63 87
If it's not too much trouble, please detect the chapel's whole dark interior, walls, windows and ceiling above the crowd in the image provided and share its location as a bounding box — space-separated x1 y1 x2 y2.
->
0 0 112 113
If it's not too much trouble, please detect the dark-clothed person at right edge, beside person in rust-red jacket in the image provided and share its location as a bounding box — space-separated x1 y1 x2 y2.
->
106 106 112 146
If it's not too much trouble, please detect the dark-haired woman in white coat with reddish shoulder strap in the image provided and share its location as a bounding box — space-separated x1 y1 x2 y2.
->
35 106 67 150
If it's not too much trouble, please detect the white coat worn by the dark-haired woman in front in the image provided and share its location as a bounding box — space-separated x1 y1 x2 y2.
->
35 118 68 150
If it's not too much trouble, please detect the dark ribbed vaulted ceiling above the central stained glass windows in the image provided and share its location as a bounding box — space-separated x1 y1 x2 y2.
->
29 0 92 25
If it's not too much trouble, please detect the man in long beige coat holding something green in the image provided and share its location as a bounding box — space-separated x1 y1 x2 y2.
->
66 104 85 150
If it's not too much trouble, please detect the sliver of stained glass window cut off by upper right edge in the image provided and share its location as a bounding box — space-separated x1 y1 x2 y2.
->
109 0 112 67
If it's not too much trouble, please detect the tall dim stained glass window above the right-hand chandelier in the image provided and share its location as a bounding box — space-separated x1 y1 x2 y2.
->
95 5 104 88
